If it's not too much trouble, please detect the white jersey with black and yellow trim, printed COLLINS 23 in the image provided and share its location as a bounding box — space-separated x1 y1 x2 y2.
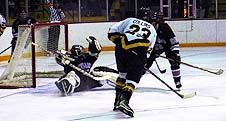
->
108 18 157 49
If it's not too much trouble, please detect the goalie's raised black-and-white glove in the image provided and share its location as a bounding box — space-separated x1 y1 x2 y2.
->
86 36 102 54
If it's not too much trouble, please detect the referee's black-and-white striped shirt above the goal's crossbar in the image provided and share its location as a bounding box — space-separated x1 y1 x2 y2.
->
49 4 65 22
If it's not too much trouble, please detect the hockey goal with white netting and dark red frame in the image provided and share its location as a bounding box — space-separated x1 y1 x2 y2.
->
0 23 68 88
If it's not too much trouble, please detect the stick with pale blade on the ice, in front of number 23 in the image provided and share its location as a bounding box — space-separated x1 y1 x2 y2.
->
146 69 196 99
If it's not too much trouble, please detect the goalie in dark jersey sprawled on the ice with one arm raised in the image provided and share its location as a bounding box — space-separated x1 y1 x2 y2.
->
55 36 117 95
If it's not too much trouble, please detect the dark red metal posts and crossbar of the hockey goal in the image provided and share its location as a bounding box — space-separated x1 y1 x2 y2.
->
0 22 69 89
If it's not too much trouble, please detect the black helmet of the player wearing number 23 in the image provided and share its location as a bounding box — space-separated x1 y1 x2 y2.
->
137 7 150 21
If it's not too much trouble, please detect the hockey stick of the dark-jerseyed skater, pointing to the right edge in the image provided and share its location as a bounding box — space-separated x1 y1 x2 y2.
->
159 55 224 75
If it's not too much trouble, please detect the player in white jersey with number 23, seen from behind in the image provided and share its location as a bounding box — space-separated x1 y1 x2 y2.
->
108 8 157 117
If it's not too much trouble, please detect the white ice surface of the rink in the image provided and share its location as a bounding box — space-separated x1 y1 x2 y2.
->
0 47 226 121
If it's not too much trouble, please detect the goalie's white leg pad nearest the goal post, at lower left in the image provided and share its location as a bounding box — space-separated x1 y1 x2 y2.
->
55 71 80 95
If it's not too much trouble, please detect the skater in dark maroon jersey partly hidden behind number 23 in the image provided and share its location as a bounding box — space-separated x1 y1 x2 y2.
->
146 12 182 89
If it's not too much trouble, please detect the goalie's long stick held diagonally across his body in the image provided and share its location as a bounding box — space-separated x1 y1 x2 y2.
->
32 42 116 84
